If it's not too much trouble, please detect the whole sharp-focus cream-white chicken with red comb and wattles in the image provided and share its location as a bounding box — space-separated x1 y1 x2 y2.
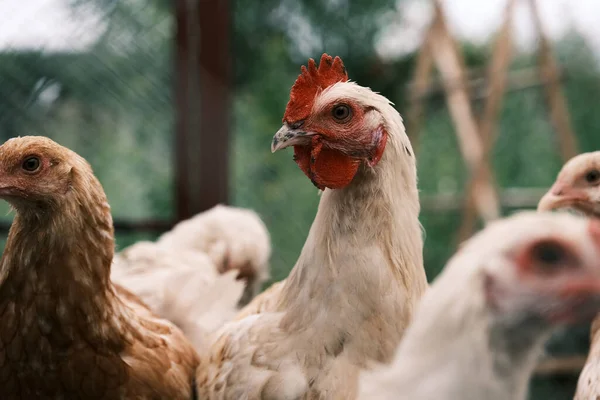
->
197 54 427 399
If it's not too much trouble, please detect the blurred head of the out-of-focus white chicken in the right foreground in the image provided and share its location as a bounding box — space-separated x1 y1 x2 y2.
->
484 215 600 325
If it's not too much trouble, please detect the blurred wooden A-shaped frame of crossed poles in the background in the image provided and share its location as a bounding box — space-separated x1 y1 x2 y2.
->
407 0 577 243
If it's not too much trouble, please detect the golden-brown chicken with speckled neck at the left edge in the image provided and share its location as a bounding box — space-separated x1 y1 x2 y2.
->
0 136 198 400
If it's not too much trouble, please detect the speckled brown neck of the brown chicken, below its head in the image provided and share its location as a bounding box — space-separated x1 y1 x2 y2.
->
0 178 129 358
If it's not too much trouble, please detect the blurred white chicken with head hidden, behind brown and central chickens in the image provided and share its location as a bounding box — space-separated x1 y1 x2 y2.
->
111 205 271 348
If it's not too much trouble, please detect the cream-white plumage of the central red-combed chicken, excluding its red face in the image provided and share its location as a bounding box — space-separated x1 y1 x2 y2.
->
197 60 427 400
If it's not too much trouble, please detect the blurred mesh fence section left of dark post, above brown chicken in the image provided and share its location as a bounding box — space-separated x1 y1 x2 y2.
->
0 1 174 245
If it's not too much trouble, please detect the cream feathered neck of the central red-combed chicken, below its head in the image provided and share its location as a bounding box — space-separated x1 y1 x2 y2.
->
279 122 427 364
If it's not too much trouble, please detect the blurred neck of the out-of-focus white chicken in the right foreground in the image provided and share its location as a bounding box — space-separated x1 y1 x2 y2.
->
388 282 551 400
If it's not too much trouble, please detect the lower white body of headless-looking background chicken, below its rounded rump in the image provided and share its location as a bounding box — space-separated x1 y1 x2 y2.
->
111 242 244 349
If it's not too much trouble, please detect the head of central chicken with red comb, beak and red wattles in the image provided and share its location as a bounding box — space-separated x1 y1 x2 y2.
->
271 54 388 189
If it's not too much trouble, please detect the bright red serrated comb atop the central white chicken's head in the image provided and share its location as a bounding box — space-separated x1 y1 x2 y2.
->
283 53 348 122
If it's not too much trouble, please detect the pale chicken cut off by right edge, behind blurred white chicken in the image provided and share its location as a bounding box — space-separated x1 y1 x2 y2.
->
538 151 600 400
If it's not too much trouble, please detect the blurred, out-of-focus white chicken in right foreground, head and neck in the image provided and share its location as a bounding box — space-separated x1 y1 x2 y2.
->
361 212 600 400
